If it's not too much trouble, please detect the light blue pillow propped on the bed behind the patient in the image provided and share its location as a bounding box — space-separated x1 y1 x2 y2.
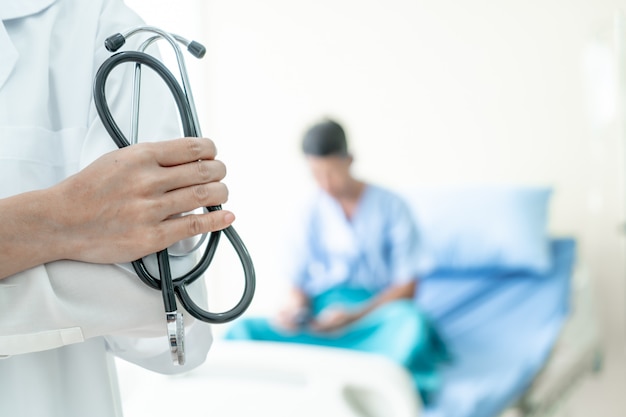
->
402 185 552 275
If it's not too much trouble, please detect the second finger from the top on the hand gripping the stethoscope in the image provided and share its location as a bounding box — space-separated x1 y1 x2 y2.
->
159 160 226 192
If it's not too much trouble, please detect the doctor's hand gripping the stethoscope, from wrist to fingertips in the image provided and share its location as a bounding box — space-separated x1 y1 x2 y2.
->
49 138 234 263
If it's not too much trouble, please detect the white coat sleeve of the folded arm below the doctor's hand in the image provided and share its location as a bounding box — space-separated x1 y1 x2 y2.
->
0 258 212 373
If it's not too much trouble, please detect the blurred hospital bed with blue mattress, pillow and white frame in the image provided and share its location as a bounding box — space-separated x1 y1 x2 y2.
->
117 187 602 417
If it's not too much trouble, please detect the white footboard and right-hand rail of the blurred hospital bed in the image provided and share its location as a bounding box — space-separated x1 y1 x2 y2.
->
120 266 601 417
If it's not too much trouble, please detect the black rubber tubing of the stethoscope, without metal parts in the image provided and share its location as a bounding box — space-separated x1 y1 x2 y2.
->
94 51 256 323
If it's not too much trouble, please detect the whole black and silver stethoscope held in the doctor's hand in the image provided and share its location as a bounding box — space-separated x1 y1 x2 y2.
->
89 26 255 365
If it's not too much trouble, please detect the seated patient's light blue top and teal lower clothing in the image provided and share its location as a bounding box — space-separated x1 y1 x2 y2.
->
226 185 446 401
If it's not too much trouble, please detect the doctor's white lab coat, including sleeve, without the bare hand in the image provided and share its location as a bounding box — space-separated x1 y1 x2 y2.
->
0 0 211 417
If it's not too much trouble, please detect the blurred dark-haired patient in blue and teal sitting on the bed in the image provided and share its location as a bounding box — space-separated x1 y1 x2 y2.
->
226 120 446 402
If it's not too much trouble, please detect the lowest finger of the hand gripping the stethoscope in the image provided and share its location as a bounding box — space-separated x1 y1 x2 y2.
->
160 210 235 247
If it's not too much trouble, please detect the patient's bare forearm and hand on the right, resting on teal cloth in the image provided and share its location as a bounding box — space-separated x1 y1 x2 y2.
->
311 280 417 332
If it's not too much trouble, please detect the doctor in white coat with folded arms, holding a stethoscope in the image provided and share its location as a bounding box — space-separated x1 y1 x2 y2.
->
0 0 234 417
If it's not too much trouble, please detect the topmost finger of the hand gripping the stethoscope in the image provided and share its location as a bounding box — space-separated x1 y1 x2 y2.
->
151 138 217 167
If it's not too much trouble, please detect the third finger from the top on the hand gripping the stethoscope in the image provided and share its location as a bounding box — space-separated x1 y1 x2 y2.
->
157 182 228 219
